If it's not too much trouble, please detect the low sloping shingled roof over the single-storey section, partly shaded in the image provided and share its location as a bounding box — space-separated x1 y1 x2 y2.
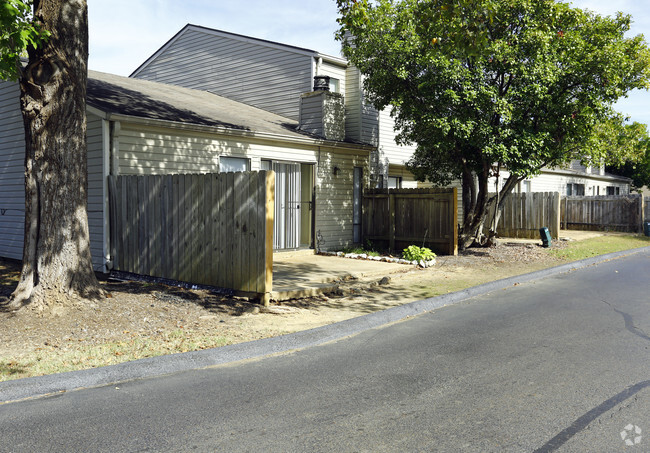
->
87 71 354 146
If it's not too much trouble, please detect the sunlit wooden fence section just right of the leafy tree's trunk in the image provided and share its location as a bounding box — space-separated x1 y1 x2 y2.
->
488 192 560 239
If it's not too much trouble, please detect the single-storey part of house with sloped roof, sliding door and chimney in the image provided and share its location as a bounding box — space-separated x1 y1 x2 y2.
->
0 71 372 271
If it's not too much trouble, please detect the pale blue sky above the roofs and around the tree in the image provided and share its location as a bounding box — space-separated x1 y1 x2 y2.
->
88 0 650 126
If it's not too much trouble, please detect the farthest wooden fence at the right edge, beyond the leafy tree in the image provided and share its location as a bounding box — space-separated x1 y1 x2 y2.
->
562 195 644 232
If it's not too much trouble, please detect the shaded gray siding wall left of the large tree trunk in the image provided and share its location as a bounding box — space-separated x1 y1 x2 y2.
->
0 81 25 260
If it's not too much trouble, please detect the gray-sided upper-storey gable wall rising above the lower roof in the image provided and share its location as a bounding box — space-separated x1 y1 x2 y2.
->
135 27 312 121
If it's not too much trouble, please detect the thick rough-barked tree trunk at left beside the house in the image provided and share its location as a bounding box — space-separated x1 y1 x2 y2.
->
10 0 102 309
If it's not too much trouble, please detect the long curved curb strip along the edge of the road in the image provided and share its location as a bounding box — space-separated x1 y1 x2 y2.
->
0 247 650 404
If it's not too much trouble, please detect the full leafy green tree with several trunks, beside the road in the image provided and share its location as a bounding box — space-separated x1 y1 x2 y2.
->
337 0 650 248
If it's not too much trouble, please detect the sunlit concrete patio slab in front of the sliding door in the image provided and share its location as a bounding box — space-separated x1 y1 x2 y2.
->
271 253 413 301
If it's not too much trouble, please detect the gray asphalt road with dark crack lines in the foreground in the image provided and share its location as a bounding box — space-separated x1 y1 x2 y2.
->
0 249 650 452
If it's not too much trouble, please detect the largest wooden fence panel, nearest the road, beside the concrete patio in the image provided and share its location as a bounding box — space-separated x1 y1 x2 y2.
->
109 171 275 303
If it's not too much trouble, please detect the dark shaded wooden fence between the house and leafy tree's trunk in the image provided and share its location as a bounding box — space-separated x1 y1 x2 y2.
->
362 188 458 255
